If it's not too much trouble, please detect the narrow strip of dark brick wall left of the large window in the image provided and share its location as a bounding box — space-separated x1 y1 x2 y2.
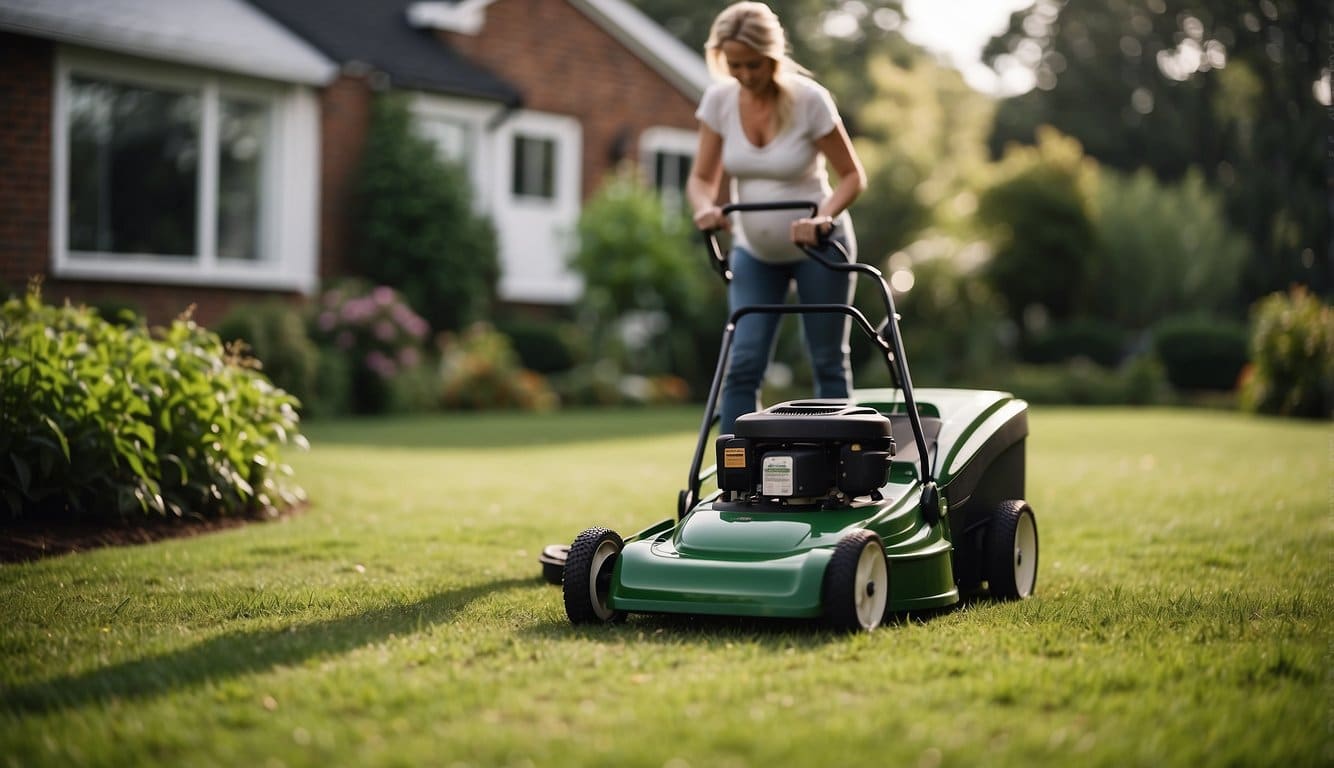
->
0 32 55 289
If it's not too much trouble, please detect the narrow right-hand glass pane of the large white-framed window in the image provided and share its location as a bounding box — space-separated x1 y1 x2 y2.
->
217 99 268 261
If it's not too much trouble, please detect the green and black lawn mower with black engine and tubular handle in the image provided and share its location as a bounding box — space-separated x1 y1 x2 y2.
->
540 201 1038 631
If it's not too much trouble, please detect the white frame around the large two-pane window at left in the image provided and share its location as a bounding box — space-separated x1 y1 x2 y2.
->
51 47 320 293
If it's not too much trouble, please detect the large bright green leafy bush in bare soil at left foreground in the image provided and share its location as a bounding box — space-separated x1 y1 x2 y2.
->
0 287 304 520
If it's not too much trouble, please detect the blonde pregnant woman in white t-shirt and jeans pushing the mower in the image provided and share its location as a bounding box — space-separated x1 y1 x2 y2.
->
686 3 866 433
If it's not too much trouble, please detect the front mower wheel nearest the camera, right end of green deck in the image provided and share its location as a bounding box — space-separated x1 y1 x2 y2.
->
823 529 890 632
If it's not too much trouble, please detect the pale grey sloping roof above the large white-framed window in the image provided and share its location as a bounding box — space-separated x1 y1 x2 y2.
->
0 0 338 85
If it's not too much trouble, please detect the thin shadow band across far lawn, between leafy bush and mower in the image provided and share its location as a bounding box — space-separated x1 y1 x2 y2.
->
301 405 702 450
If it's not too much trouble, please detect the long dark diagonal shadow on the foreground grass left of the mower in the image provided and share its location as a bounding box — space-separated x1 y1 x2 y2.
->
0 579 538 715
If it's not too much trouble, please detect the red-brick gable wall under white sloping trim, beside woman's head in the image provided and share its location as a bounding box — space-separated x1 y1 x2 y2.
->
442 0 696 199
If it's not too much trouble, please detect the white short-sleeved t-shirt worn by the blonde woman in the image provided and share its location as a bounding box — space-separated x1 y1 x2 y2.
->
695 75 855 263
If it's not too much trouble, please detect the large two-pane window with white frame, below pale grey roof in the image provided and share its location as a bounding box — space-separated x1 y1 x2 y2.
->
53 55 317 288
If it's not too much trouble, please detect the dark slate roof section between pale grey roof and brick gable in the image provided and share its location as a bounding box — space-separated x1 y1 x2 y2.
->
245 0 520 104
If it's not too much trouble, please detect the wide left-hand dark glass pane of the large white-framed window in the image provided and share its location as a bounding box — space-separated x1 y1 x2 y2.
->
68 76 199 257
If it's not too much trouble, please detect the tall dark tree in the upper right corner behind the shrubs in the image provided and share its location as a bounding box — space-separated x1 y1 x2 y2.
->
984 0 1334 303
